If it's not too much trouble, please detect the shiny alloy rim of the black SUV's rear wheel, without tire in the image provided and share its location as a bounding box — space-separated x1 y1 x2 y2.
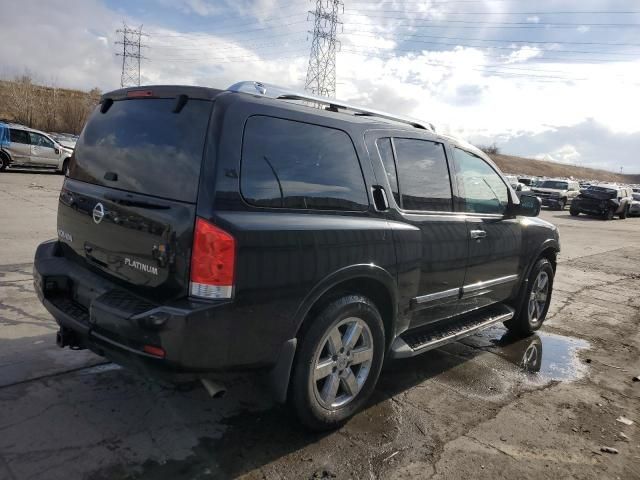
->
310 317 373 410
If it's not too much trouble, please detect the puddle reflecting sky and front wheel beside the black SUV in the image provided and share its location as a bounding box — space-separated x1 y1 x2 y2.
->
462 327 590 381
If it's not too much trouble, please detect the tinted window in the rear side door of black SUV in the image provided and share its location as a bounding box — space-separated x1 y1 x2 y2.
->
393 138 452 211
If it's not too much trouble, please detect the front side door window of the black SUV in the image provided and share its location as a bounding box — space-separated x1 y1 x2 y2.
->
454 148 509 214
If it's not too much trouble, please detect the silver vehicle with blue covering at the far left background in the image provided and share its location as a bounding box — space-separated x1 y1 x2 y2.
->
0 123 73 173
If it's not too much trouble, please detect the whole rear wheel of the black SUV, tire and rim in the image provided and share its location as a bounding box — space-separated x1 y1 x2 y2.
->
289 294 385 431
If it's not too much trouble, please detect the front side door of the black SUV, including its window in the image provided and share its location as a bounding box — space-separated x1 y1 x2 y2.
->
454 148 522 311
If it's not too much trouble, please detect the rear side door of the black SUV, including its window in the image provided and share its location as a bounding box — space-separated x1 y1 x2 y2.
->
367 135 468 328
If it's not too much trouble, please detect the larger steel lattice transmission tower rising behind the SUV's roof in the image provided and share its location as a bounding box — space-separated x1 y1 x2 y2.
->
304 0 344 97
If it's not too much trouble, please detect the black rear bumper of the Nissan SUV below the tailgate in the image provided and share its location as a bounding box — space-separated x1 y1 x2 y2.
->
33 241 288 380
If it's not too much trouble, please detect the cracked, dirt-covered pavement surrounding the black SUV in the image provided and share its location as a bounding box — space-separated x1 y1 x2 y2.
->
0 172 640 480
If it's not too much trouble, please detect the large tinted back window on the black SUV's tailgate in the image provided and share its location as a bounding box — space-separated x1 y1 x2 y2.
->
70 99 213 202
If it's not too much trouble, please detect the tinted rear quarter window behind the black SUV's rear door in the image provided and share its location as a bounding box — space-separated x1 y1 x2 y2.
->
241 116 368 210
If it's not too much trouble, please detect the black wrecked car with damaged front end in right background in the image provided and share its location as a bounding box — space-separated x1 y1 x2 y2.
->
569 185 633 220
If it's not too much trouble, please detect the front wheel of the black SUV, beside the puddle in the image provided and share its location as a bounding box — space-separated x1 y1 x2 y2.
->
504 258 554 337
